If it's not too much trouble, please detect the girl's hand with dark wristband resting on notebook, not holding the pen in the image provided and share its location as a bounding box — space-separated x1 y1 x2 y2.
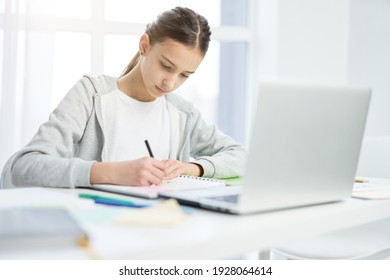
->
162 159 203 180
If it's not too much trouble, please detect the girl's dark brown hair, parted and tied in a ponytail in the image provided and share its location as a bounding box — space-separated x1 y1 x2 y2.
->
122 7 211 76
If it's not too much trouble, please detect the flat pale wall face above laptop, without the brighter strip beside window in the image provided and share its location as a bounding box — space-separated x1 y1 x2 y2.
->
278 0 349 83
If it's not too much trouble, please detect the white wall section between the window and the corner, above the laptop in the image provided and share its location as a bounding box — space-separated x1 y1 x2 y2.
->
256 0 349 83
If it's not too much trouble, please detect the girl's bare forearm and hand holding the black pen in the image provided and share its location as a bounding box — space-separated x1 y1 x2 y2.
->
90 157 165 186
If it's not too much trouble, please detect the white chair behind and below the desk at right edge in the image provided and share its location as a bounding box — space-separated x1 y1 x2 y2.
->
270 136 390 260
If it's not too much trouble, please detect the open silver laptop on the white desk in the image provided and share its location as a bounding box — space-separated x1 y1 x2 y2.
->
164 82 371 214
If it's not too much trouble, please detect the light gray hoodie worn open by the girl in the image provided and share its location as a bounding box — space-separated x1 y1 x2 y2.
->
1 75 246 188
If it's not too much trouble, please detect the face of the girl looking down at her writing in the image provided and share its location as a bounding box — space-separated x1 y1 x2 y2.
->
140 35 203 100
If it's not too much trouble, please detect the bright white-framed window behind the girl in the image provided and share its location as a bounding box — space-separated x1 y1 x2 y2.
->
0 0 253 167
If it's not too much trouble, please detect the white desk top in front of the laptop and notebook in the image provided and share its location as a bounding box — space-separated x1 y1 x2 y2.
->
0 189 390 259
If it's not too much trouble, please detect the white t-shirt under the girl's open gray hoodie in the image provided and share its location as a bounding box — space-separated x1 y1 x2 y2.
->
102 89 170 161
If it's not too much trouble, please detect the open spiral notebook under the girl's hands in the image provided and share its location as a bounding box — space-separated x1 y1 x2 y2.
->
80 175 225 199
